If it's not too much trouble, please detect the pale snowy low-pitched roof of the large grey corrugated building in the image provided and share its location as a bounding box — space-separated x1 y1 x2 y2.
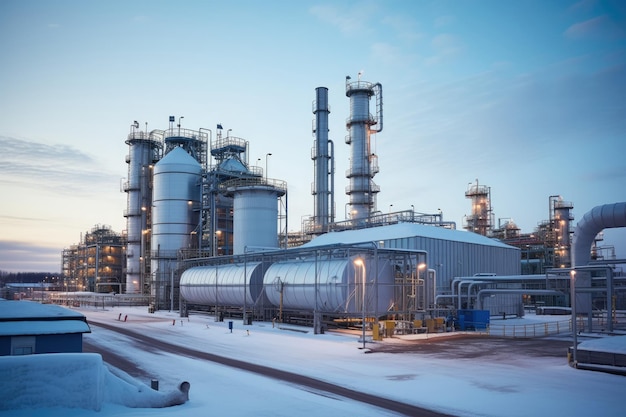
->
303 223 517 250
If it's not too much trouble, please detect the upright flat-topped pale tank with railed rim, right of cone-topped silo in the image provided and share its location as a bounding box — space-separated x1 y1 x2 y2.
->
229 184 284 255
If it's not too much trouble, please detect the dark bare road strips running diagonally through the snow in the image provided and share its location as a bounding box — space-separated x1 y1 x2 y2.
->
83 320 452 417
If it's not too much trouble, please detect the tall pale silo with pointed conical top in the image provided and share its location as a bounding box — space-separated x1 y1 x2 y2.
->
150 147 202 309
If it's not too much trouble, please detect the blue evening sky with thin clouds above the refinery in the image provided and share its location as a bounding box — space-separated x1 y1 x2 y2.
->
0 0 626 272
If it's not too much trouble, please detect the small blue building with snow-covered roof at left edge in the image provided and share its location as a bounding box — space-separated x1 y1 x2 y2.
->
0 300 91 356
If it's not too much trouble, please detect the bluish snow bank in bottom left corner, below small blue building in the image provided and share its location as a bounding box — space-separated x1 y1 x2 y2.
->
0 353 189 411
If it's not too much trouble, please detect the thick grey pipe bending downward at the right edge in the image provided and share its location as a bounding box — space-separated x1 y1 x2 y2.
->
572 202 626 266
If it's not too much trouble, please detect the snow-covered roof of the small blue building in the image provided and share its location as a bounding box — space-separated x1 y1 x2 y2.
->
0 300 91 336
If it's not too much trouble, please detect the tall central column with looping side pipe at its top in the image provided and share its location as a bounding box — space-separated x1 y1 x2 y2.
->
346 73 383 224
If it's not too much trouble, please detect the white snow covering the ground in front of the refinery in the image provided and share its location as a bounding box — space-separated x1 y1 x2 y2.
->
0 307 626 417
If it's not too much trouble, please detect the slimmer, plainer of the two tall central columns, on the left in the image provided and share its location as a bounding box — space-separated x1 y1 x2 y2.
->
311 87 334 233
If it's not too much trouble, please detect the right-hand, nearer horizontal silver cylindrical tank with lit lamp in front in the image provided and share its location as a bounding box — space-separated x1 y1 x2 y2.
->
263 257 394 314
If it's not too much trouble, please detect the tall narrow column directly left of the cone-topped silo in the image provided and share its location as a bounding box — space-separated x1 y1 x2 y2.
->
123 127 163 294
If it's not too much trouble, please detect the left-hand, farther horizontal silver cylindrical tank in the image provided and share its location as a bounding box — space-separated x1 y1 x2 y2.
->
180 262 263 307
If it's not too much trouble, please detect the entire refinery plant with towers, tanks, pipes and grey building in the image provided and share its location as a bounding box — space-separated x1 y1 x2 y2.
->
63 74 626 332
